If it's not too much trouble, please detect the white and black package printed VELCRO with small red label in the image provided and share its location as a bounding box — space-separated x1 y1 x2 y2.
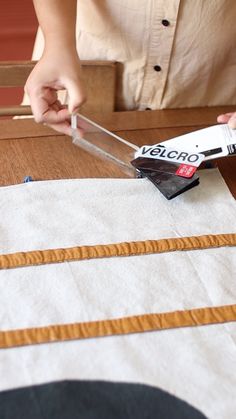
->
131 124 236 199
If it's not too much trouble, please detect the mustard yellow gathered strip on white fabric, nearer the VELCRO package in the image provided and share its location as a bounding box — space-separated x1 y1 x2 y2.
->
0 234 236 269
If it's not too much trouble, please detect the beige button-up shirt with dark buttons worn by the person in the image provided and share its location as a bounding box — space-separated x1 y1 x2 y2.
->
34 0 236 110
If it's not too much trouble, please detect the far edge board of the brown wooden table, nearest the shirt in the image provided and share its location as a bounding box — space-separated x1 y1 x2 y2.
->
0 106 232 139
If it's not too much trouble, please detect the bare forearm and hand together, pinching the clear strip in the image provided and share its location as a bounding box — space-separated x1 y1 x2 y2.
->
25 0 86 127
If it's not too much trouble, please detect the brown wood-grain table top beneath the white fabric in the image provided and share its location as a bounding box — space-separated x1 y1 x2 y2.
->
0 107 236 198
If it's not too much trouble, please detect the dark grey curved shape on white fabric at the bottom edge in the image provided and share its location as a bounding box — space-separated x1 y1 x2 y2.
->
0 381 206 419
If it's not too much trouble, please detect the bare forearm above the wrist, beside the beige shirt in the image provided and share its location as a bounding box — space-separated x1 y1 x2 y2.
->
33 0 77 49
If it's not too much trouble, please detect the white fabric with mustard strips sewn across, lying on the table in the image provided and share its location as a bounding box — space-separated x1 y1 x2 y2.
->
0 170 236 419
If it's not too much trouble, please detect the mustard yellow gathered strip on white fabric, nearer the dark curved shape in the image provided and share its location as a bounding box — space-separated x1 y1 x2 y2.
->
0 304 236 348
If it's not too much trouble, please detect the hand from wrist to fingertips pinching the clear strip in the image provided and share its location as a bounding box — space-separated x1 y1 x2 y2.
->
25 49 85 135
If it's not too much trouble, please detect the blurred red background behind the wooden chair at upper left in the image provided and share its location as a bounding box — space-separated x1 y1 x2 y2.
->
0 0 38 106
